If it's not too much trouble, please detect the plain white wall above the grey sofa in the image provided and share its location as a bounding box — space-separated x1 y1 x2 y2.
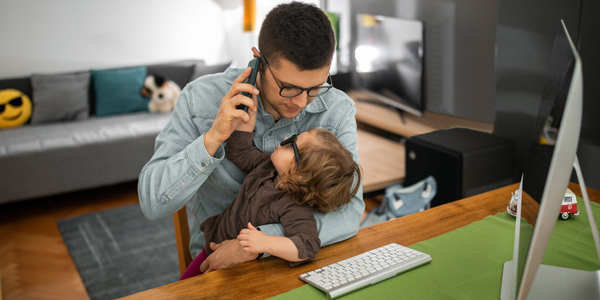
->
0 0 229 78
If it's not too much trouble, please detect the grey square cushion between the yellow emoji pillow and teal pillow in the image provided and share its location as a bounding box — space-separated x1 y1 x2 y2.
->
31 72 90 124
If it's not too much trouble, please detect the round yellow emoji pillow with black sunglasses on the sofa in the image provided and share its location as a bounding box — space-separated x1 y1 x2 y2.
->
0 89 31 129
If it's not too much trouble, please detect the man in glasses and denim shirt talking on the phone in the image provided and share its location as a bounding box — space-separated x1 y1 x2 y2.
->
138 2 364 272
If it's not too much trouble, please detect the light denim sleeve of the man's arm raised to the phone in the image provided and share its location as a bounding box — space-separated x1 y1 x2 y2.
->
138 87 225 220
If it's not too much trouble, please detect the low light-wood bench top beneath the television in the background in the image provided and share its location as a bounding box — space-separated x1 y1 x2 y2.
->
348 91 494 138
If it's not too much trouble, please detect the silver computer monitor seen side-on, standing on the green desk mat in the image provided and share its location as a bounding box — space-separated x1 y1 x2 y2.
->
501 20 598 299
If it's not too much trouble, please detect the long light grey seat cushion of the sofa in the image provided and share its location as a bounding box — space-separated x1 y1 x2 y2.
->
0 112 171 159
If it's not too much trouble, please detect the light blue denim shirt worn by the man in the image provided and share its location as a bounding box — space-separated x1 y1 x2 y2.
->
138 69 365 257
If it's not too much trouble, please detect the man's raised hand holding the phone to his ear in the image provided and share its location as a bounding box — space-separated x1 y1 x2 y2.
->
204 64 259 156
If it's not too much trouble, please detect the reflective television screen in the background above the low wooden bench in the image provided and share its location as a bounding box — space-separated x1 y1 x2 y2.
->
354 14 424 116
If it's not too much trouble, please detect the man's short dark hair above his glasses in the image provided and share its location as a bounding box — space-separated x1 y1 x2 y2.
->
258 2 336 71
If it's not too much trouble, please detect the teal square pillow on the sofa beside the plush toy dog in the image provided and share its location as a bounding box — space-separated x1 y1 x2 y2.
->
91 67 148 116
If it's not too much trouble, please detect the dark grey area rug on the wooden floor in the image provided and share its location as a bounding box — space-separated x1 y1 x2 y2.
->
57 204 192 300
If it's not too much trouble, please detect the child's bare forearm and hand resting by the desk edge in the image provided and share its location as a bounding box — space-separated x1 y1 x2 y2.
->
238 223 306 261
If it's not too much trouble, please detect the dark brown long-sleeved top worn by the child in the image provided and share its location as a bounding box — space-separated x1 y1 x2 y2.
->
200 131 321 267
